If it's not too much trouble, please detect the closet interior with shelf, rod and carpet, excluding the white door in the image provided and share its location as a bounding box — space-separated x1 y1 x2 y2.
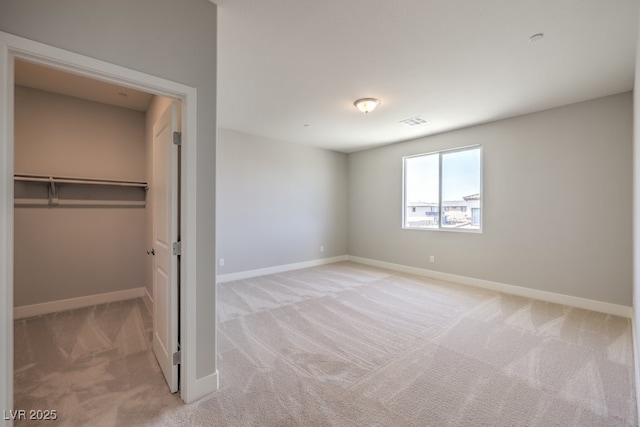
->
13 61 181 413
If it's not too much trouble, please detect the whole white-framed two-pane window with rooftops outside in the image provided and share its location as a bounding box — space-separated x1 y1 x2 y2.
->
403 145 482 231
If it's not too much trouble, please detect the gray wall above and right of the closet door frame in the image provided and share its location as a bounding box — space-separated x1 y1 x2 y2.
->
0 0 217 378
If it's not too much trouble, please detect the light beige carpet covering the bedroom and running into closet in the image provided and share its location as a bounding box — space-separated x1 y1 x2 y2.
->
16 263 637 426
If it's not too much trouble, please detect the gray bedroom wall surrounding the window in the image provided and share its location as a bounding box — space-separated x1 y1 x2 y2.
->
348 93 633 306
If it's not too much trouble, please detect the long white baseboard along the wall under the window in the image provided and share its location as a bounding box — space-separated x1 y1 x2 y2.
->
348 255 632 318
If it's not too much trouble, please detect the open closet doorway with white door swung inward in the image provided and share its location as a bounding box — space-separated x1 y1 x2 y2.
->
14 56 179 392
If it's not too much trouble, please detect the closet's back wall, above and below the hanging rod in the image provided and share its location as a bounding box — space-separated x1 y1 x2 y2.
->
14 86 145 306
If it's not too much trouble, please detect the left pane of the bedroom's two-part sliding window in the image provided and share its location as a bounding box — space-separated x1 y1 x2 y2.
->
404 153 440 228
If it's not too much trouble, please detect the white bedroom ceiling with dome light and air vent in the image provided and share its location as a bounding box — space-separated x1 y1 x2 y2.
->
212 0 638 152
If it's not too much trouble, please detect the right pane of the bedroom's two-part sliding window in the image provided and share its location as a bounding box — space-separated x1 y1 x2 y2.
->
442 148 481 230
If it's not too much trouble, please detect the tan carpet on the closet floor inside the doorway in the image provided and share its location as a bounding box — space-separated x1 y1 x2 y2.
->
14 298 184 426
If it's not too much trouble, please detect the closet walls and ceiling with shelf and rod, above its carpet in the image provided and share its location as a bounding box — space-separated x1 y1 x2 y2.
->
14 61 170 317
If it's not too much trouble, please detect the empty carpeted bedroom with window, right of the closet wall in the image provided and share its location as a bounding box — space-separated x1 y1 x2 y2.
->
215 1 638 426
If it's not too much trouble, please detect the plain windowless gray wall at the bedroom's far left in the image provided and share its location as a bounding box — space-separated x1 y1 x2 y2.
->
217 129 347 274
